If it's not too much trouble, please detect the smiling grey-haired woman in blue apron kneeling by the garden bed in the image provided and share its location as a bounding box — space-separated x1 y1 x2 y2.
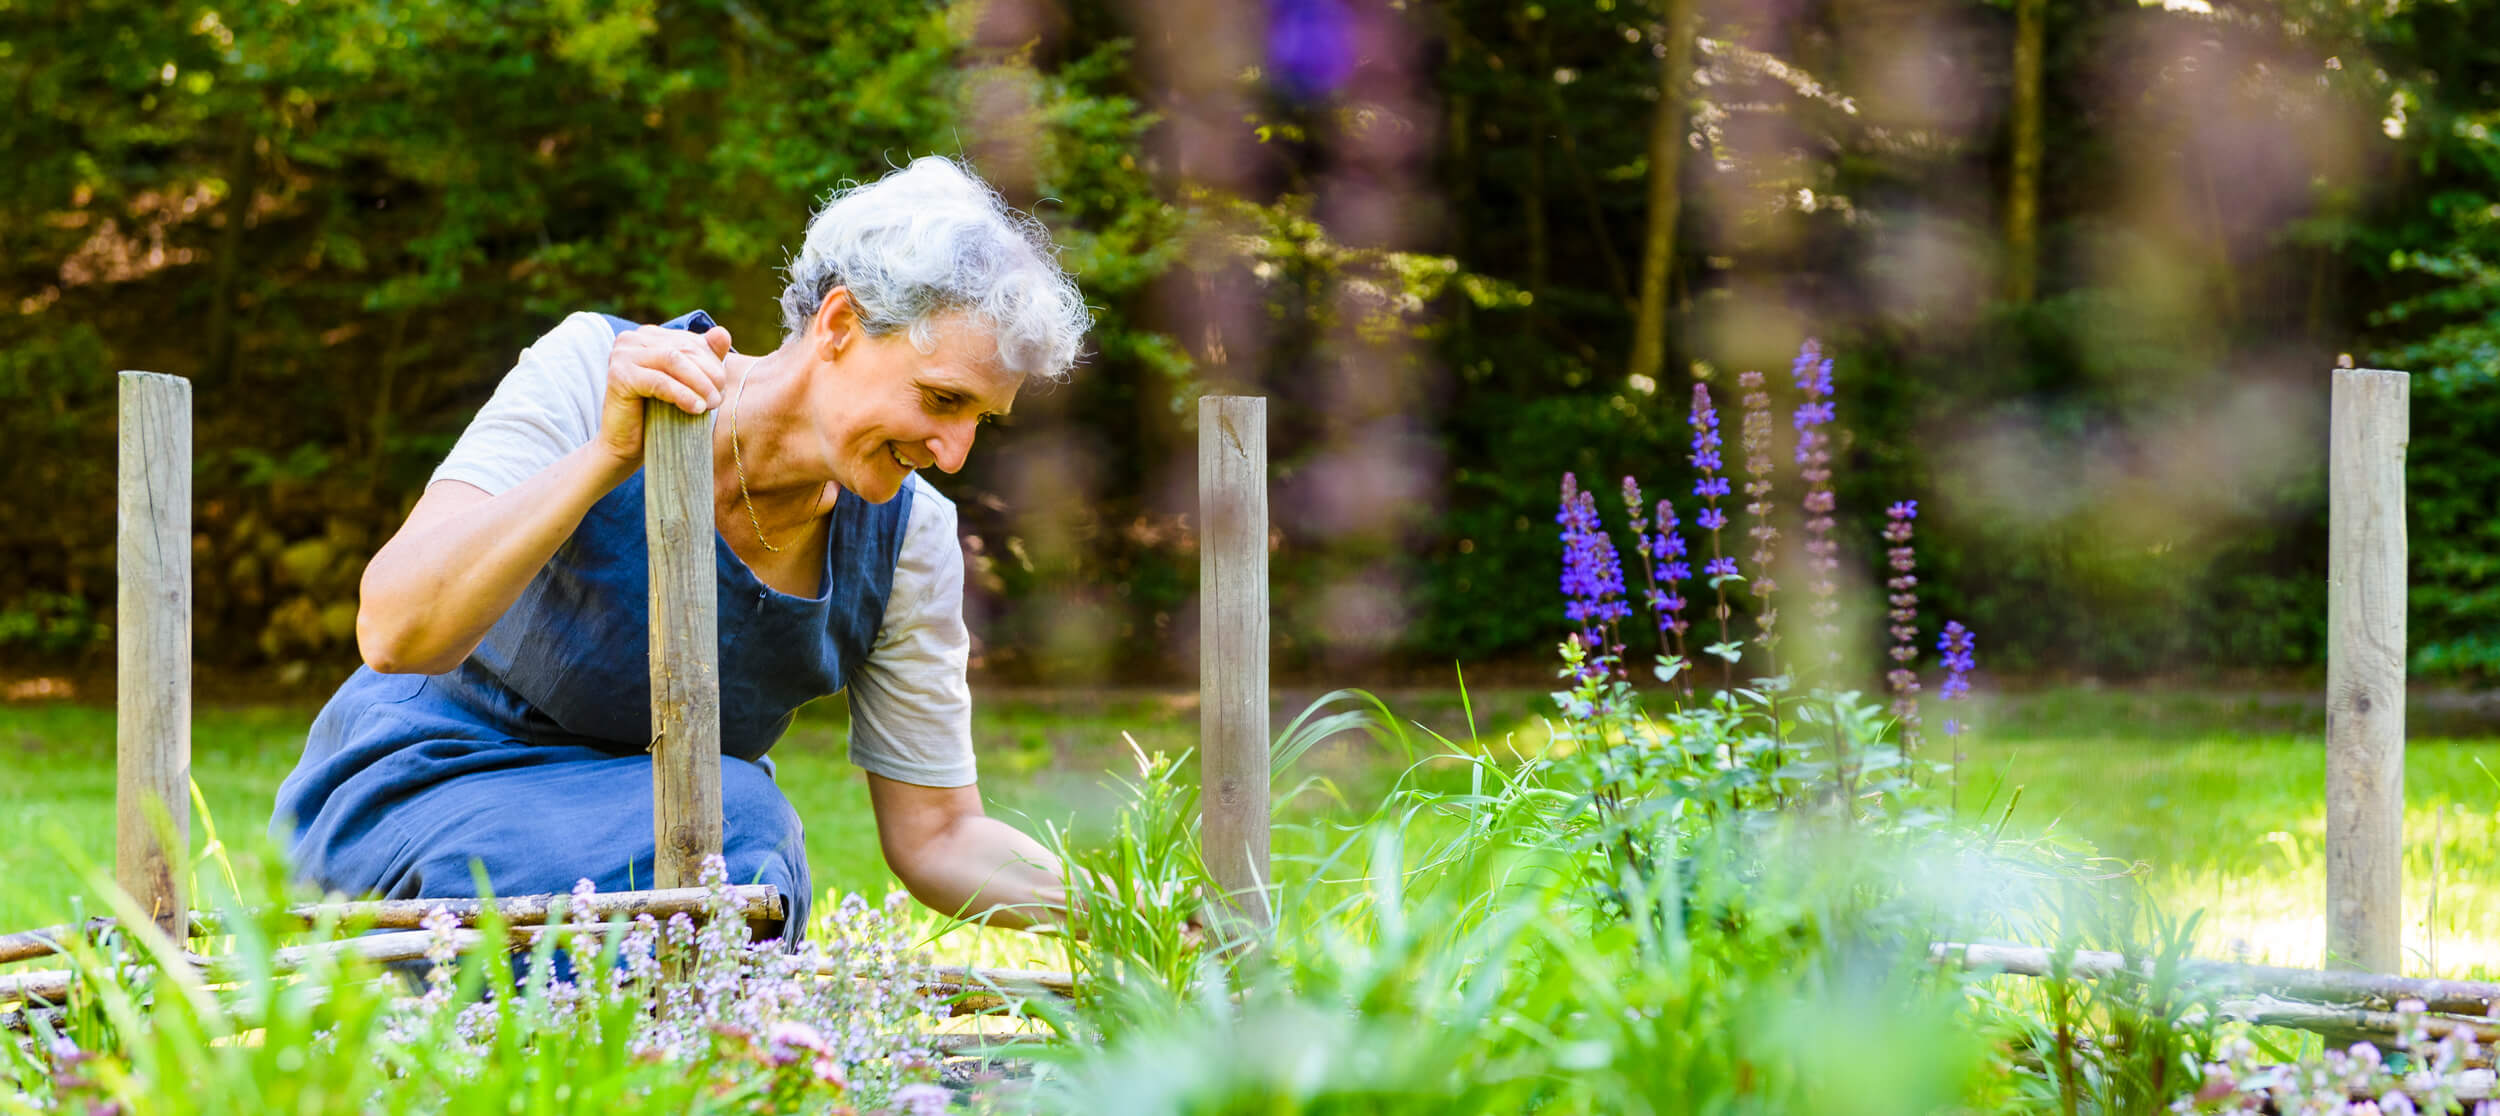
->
270 158 1088 928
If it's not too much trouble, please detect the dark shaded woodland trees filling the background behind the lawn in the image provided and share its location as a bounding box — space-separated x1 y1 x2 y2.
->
0 0 2500 683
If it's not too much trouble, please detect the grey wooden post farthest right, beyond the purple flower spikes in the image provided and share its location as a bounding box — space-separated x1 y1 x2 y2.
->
2328 368 2410 973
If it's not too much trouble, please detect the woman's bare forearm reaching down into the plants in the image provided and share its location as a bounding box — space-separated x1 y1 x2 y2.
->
868 773 1068 928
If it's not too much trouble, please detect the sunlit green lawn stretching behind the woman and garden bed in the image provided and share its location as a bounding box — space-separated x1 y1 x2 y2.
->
0 691 2500 976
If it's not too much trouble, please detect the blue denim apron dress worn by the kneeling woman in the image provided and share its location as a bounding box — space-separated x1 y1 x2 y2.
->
270 310 913 936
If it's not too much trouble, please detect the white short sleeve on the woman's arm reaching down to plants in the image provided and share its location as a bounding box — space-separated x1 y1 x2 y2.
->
848 475 978 786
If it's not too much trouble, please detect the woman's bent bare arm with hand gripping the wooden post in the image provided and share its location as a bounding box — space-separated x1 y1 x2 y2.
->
355 325 730 673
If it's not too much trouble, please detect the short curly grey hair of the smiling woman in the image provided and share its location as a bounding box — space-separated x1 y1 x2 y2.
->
783 155 1093 380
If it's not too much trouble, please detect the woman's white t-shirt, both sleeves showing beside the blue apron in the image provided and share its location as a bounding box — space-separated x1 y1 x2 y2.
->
433 313 978 786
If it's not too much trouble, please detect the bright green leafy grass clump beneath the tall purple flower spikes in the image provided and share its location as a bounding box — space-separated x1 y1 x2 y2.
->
1020 643 2130 1113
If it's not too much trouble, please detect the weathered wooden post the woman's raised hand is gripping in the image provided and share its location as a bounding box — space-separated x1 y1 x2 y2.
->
643 400 720 888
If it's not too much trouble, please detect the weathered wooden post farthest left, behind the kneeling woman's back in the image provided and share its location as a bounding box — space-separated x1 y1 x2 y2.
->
113 373 190 941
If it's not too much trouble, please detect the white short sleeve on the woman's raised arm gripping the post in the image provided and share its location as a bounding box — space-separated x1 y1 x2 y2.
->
433 313 615 495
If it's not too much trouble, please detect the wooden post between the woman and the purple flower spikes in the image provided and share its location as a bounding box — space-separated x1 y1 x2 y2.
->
1198 395 1270 926
